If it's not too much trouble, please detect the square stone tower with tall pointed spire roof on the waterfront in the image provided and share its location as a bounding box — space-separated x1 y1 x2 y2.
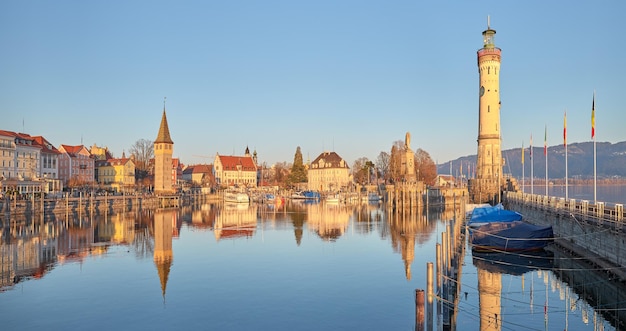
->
154 101 174 195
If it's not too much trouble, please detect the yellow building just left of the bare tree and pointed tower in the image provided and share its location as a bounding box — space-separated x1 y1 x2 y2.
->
96 157 135 192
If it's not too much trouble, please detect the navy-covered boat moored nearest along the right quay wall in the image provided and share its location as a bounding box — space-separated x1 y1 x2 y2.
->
470 221 554 252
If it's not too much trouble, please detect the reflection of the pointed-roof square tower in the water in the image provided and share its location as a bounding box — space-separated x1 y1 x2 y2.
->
154 209 178 302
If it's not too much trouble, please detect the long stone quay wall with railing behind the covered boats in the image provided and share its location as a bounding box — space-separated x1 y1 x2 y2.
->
505 192 626 281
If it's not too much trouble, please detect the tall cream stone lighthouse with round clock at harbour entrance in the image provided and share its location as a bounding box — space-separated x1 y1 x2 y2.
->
469 19 502 203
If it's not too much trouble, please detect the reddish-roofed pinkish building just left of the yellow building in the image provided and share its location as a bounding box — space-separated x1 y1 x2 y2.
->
59 144 95 187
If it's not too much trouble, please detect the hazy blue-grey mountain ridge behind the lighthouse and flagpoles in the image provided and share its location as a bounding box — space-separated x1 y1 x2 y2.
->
437 141 626 179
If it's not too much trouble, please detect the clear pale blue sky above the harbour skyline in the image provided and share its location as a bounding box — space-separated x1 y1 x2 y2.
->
0 0 626 169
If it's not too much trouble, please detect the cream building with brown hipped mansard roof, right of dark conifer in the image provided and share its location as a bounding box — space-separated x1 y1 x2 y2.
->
307 152 352 192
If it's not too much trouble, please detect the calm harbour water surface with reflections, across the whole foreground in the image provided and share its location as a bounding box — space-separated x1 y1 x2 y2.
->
0 196 626 330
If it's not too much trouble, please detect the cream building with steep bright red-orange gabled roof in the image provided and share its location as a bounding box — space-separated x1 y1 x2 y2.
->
213 147 257 187
